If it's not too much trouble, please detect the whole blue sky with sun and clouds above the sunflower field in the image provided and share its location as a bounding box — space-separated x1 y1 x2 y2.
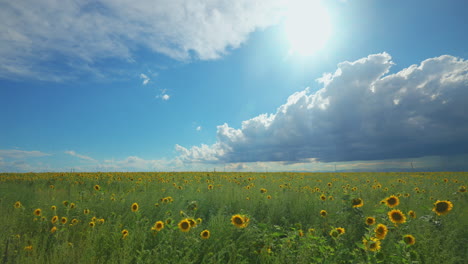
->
0 0 468 172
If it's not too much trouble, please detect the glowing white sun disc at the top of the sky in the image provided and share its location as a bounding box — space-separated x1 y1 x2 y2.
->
284 0 332 56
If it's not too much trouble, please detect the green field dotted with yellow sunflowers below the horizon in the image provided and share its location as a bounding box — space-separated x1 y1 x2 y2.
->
0 172 468 264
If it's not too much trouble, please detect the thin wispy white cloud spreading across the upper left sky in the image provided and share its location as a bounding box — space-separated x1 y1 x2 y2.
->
0 0 285 80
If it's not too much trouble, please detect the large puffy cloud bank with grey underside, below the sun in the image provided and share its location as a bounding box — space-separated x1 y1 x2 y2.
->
175 53 468 163
